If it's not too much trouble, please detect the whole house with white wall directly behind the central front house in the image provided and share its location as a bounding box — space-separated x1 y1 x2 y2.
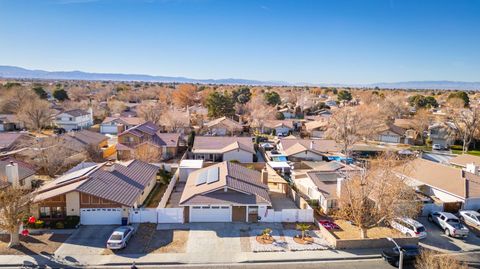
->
191 136 255 163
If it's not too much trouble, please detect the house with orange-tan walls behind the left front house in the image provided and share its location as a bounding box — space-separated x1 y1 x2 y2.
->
117 121 180 161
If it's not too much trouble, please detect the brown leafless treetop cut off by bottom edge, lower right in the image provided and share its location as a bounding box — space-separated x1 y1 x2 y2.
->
415 249 468 269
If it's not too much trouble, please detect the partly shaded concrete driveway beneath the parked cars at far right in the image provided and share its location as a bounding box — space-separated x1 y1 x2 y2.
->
419 217 480 251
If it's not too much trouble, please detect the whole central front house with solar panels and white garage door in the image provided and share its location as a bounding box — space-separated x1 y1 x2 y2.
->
179 161 272 222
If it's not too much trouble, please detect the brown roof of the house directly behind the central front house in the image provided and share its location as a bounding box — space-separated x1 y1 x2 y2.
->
192 136 255 153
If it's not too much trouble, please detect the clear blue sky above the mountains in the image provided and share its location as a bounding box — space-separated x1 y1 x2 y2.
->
0 0 480 83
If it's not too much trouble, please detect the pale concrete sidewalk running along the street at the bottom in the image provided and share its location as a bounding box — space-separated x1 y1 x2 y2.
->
0 249 381 268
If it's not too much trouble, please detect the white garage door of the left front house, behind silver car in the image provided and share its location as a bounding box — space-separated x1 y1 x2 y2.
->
80 208 122 225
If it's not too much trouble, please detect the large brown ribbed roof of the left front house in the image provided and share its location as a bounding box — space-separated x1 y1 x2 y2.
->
34 160 159 206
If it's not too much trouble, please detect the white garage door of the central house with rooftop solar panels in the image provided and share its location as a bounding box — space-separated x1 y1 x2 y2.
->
190 206 232 222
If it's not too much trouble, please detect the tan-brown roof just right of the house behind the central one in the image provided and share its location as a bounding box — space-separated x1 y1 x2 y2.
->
280 139 340 156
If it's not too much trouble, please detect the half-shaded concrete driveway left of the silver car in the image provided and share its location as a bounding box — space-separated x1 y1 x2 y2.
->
55 225 118 255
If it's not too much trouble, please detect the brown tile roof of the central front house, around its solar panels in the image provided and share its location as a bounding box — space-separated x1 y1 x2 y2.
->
180 162 271 205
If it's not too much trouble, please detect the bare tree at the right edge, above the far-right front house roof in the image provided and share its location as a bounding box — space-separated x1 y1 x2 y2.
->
450 107 480 153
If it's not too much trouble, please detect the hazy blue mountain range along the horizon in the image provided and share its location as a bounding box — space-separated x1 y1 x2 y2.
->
0 65 480 90
